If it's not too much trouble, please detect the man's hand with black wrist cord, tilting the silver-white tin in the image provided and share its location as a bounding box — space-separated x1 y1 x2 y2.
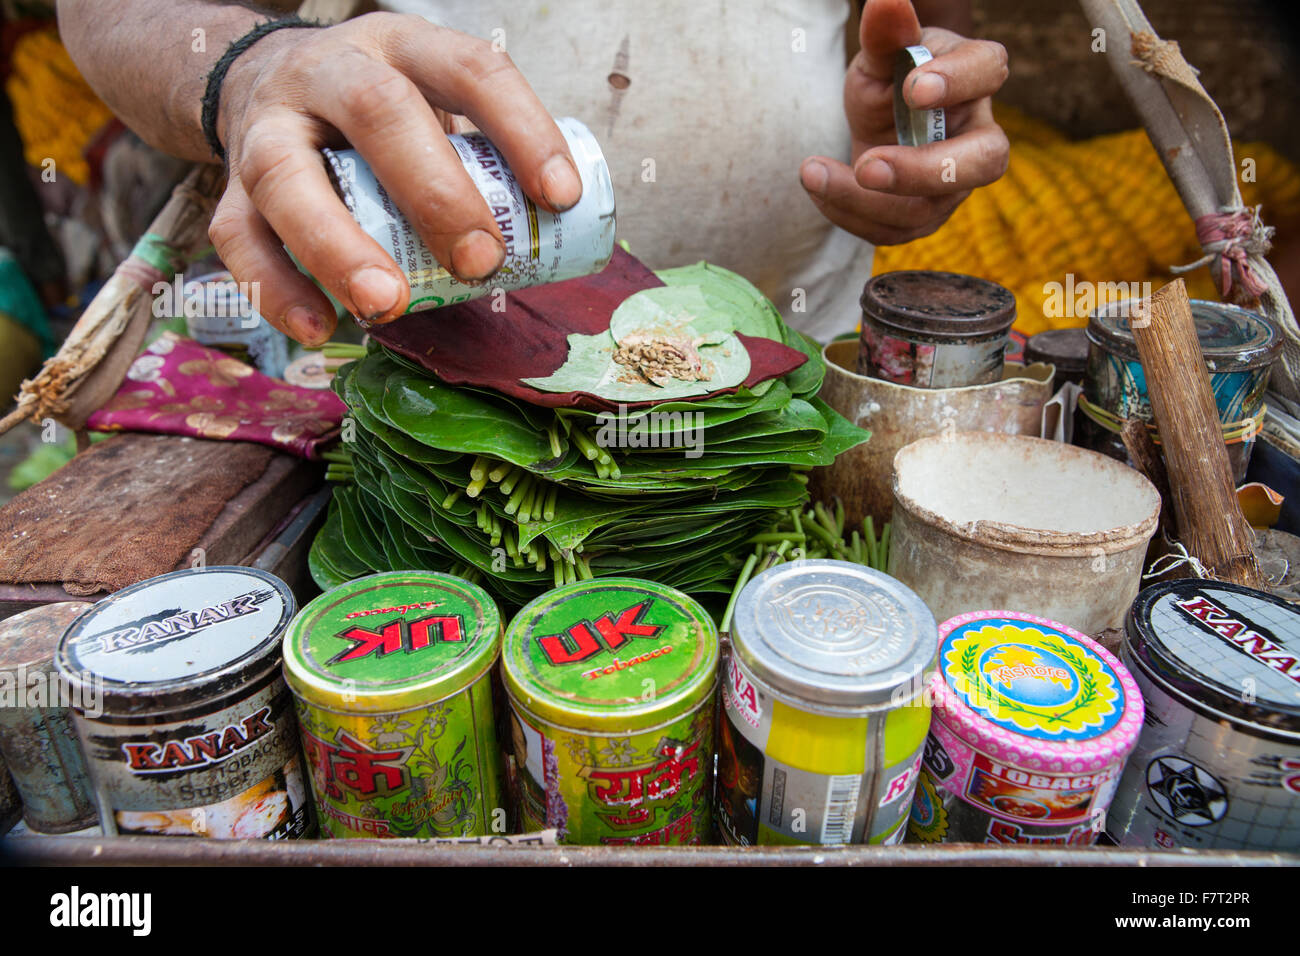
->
209 13 582 345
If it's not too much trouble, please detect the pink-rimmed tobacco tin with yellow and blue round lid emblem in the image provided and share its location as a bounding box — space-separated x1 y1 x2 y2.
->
909 611 1143 844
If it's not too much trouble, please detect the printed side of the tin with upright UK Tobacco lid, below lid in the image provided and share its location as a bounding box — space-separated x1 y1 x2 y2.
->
508 696 714 845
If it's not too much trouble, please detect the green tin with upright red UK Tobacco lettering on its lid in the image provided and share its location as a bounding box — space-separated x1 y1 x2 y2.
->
502 578 718 845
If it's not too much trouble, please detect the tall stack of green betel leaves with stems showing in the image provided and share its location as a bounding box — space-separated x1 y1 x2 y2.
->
309 267 867 605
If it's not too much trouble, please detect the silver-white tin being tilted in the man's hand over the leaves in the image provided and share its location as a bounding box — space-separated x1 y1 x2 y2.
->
325 118 614 312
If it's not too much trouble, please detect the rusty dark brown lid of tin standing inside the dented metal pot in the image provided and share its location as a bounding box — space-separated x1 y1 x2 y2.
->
861 271 1015 338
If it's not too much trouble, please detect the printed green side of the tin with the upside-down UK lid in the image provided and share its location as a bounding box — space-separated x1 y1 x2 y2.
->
298 675 507 838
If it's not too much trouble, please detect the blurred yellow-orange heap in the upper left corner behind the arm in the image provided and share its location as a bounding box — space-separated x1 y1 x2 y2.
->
5 26 113 186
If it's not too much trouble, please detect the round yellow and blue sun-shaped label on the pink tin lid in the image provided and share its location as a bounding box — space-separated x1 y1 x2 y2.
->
939 618 1125 740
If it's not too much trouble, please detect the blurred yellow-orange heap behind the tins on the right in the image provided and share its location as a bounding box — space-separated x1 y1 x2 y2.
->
872 104 1300 336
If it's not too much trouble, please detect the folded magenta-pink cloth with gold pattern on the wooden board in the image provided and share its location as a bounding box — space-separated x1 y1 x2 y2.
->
86 332 347 458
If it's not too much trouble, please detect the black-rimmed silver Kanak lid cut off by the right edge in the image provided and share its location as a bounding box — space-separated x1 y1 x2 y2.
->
1125 579 1300 734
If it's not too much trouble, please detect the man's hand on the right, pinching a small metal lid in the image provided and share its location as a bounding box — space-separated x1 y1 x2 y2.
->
800 0 1010 246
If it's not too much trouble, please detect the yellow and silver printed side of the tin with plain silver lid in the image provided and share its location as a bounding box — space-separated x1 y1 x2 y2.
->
716 656 930 847
